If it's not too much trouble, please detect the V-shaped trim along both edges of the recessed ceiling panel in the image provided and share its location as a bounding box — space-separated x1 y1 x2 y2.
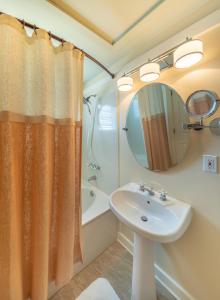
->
47 0 165 45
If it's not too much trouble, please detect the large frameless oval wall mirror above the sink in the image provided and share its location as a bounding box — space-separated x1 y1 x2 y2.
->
126 83 189 171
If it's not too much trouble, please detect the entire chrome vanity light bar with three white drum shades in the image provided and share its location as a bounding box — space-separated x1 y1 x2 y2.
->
117 38 203 92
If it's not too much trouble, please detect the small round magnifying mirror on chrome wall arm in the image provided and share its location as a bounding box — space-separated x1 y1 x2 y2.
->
185 90 219 119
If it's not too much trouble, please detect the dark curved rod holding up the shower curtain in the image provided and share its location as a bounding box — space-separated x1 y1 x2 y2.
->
0 11 115 78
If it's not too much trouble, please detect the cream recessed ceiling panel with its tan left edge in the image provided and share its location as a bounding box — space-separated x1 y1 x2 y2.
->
48 0 164 44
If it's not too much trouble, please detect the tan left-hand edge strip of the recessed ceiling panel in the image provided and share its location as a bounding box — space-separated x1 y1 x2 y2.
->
47 0 113 44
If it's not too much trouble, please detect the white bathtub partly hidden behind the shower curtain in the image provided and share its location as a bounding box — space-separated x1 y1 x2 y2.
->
48 182 118 298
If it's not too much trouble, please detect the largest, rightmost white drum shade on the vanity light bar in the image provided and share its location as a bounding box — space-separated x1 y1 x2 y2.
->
173 39 203 69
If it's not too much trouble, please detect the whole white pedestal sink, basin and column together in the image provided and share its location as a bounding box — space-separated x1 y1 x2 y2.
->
110 183 192 300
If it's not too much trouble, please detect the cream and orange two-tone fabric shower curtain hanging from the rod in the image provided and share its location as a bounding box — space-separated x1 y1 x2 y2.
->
0 15 83 300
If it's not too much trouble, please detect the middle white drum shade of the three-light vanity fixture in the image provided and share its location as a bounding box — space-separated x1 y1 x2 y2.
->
140 62 160 82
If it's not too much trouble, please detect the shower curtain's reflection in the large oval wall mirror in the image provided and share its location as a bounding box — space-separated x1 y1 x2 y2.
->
138 85 172 171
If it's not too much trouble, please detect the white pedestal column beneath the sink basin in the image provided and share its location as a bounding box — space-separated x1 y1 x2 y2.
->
132 233 157 300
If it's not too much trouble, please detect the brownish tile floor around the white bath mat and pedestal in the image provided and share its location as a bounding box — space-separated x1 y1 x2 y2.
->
50 242 175 300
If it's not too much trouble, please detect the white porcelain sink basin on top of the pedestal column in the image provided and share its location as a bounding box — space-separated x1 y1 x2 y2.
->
110 183 192 243
